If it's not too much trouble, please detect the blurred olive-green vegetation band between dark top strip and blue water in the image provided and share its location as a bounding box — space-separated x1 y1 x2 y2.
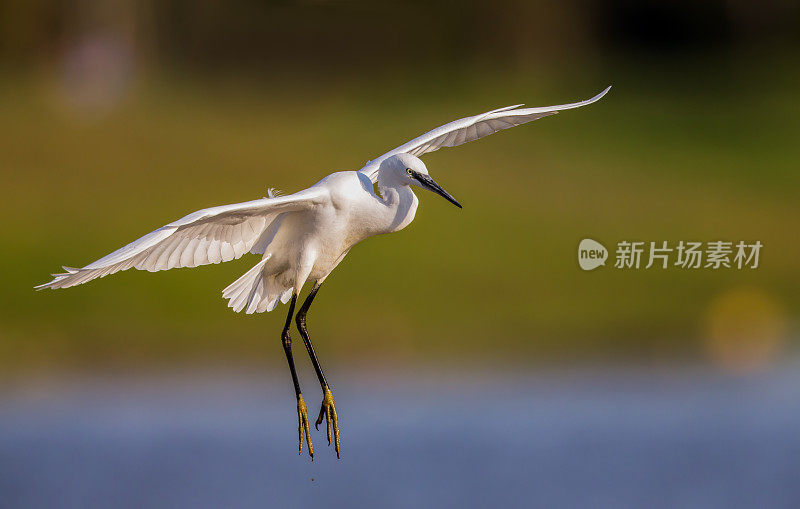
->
0 58 800 373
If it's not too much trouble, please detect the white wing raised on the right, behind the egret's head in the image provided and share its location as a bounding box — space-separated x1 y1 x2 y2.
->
359 87 611 182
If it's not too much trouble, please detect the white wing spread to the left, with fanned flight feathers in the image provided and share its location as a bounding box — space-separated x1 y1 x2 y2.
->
36 187 325 290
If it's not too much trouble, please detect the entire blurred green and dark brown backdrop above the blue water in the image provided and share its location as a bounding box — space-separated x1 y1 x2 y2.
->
0 0 800 376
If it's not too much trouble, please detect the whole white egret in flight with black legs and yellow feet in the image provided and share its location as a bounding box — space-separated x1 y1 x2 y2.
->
36 87 611 459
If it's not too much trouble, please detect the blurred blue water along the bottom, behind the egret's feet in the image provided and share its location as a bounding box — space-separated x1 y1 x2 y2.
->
0 369 800 508
